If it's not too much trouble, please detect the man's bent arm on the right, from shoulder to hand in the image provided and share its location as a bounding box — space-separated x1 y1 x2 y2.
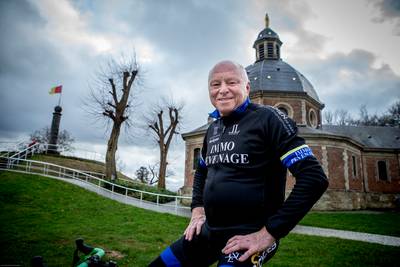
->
222 108 328 261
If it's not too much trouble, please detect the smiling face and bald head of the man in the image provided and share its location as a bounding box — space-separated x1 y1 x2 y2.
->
208 63 250 116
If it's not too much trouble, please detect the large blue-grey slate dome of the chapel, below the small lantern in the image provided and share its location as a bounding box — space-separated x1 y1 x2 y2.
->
246 60 321 103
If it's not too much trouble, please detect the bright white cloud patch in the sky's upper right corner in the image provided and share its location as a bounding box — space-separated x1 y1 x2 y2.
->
304 0 400 74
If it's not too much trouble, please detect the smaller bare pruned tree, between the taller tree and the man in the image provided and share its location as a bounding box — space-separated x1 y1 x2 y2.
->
145 99 183 189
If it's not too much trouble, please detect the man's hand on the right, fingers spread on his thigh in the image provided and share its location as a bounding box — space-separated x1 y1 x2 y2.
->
222 227 275 262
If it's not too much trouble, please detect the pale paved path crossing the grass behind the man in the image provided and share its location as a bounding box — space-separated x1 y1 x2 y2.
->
39 177 400 247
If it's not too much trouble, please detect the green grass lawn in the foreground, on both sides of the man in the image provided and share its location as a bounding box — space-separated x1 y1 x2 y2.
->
0 172 400 266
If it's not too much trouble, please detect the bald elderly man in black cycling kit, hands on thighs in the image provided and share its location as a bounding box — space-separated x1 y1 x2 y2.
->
149 61 328 267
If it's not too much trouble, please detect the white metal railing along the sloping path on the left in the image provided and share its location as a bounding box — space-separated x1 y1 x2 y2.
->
0 157 191 216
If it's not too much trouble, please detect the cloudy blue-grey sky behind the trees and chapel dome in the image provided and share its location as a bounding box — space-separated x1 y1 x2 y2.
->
0 0 400 193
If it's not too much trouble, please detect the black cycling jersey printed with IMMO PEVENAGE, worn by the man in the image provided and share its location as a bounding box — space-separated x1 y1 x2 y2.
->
192 100 328 239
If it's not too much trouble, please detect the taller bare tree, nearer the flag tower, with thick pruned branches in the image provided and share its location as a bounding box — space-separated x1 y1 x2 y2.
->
85 56 139 180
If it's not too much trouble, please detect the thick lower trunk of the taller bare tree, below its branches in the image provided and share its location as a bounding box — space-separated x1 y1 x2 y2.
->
106 124 121 181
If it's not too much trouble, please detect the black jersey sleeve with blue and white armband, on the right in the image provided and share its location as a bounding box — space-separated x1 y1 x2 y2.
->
260 109 329 239
